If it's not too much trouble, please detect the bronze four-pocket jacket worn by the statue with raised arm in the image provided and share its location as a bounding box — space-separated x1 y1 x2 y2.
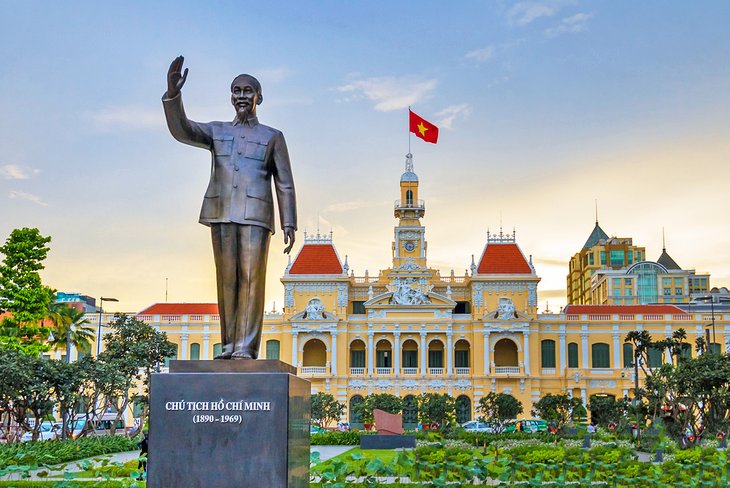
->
162 94 297 233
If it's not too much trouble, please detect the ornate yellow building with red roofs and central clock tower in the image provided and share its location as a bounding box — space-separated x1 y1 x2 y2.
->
79 157 730 425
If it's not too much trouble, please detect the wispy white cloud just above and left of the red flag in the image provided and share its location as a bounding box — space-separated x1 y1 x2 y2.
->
337 76 437 112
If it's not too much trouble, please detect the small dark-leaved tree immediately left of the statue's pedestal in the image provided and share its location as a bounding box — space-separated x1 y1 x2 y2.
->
99 315 177 425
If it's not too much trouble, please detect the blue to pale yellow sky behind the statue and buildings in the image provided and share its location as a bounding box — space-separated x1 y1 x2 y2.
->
0 0 730 312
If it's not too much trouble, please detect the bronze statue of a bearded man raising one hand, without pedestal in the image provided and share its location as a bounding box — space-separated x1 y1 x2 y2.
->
162 56 297 359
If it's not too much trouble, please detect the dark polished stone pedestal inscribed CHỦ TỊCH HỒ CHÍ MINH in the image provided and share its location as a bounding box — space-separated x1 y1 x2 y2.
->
147 360 310 488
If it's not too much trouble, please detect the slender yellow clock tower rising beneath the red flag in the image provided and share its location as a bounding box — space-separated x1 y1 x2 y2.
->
393 153 426 271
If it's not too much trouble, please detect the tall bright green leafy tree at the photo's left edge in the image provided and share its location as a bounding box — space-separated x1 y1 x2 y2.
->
0 228 53 355
